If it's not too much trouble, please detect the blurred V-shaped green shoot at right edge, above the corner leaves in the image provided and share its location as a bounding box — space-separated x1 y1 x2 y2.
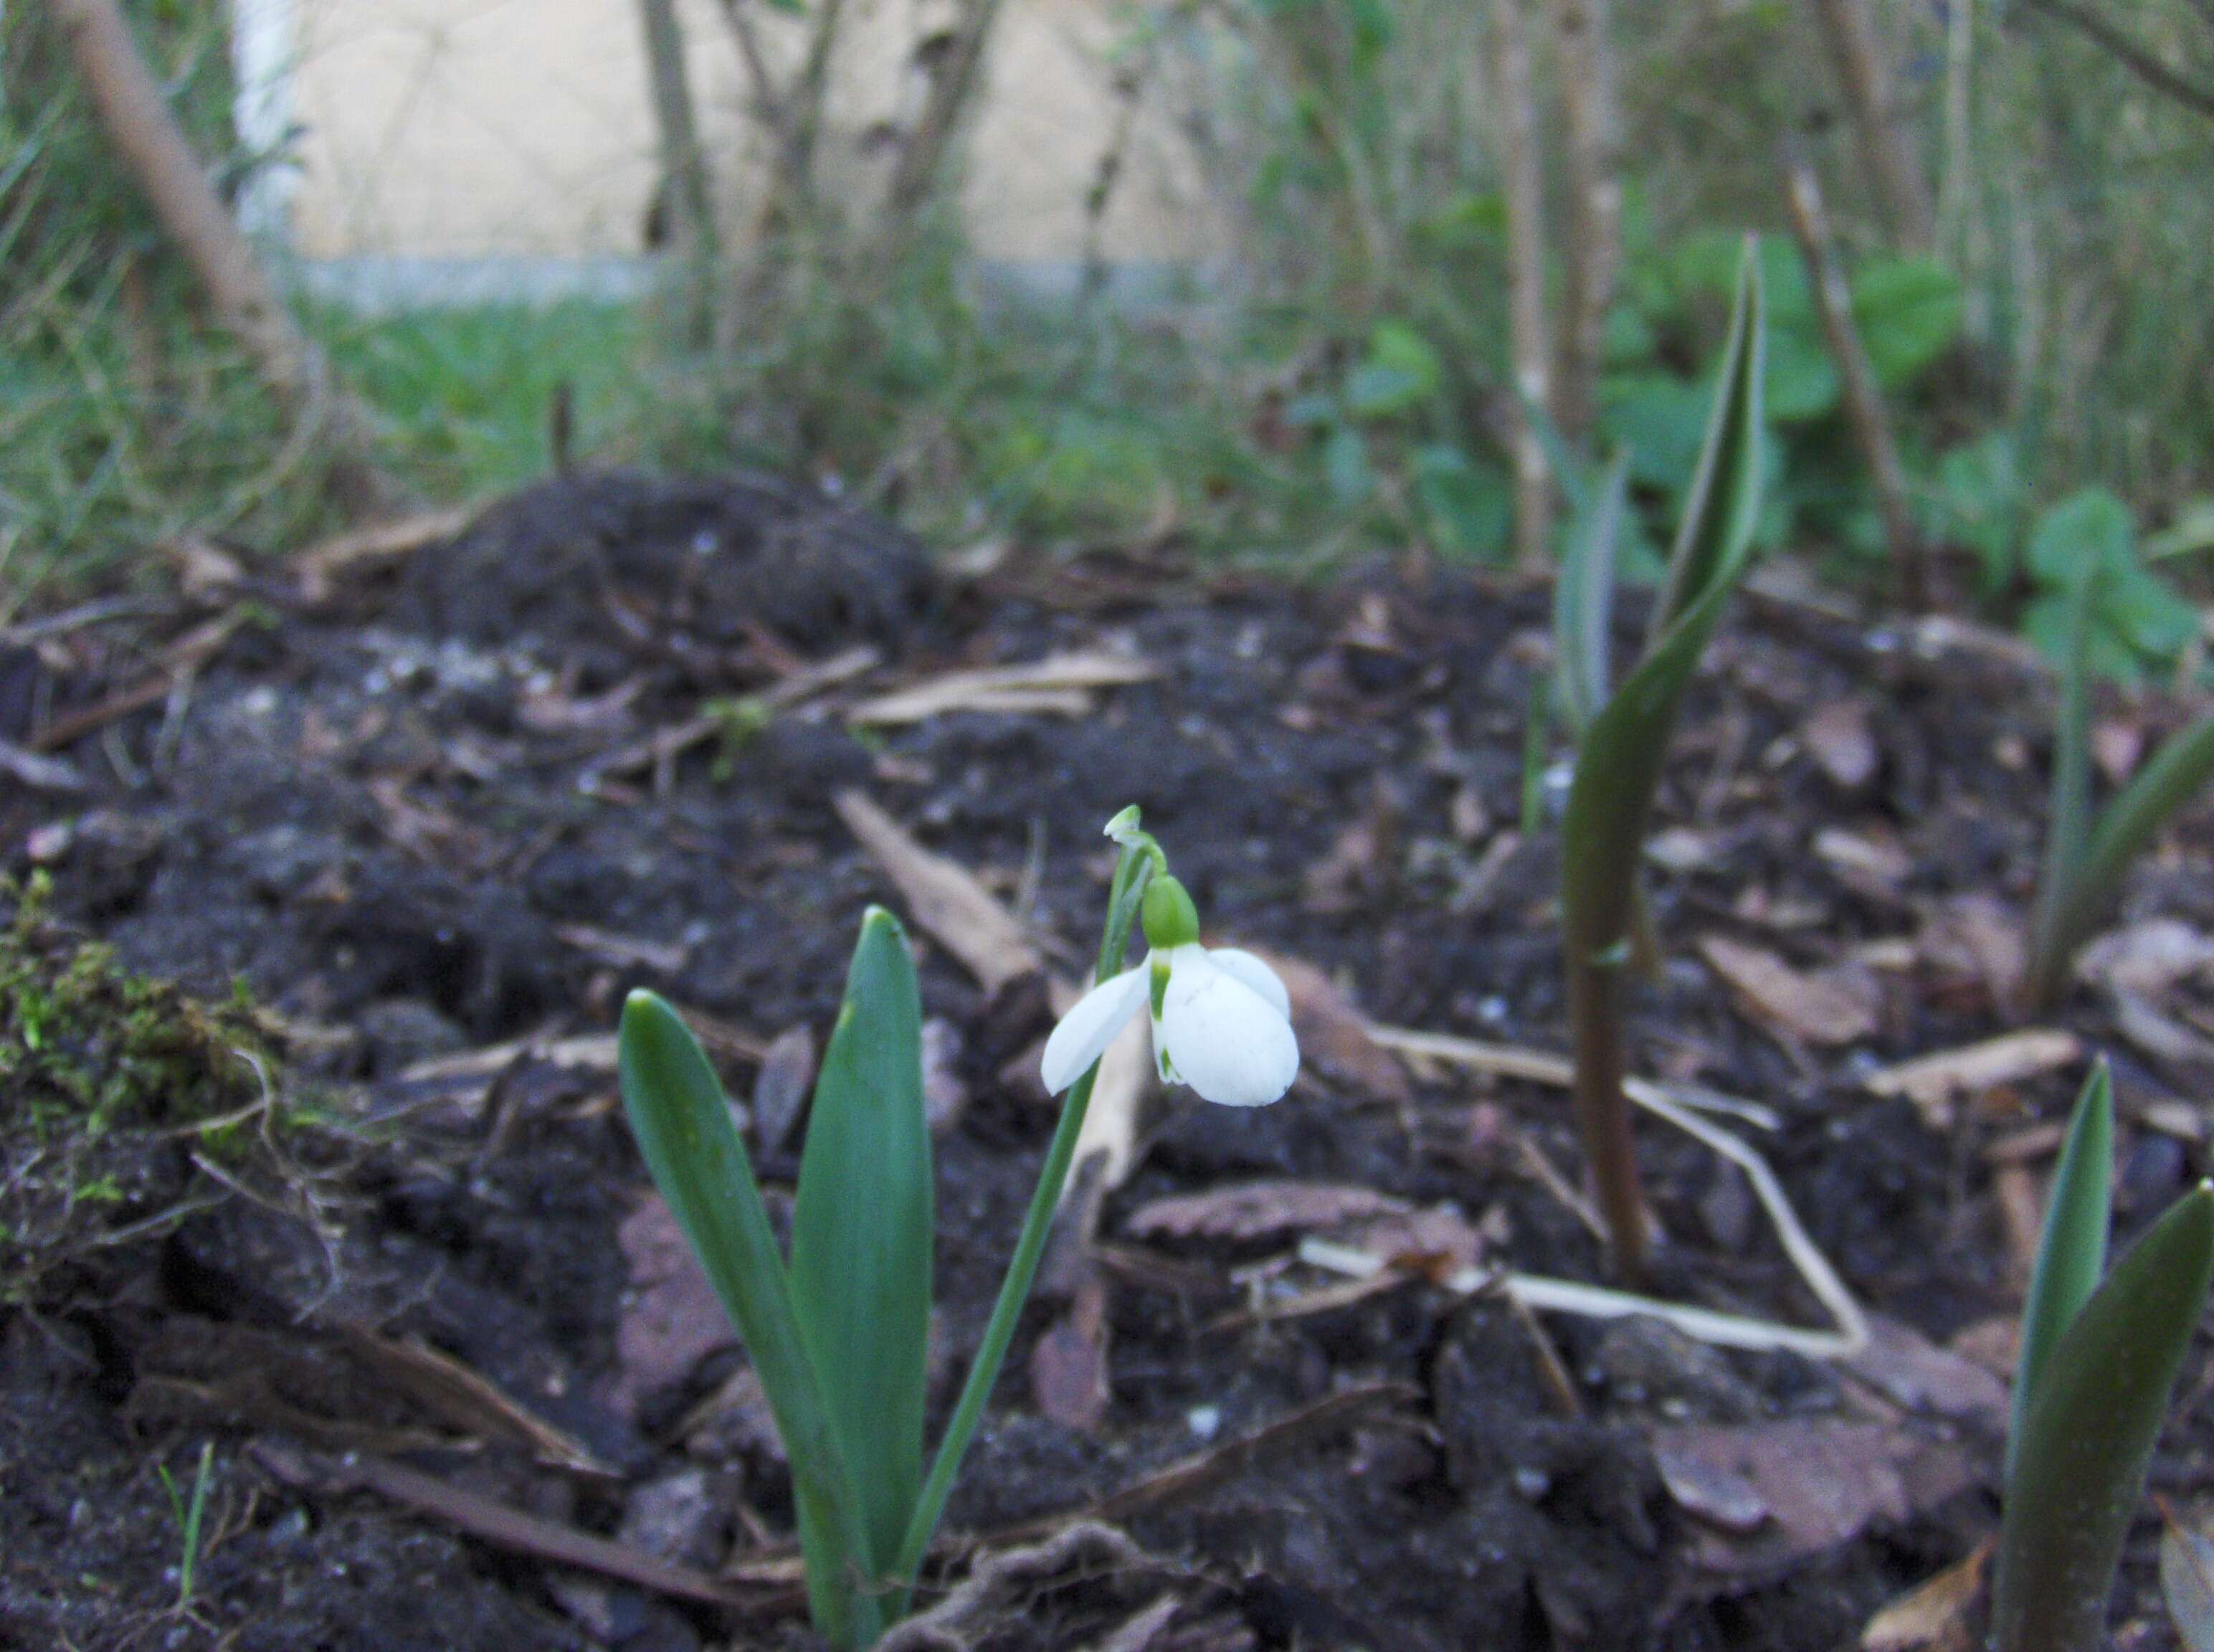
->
2023 558 2214 1010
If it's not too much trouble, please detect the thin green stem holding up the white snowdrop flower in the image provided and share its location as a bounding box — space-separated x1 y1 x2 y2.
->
892 832 1164 1585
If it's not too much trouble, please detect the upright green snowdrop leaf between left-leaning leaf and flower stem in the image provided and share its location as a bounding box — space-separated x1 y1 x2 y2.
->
790 906 932 1575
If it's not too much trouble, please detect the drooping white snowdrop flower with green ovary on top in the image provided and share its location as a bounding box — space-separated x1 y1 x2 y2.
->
1038 877 1300 1107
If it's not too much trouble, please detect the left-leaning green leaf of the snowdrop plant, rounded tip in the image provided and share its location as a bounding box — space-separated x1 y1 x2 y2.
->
618 992 883 1646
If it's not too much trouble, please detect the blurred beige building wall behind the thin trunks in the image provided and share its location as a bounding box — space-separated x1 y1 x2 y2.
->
290 0 1213 261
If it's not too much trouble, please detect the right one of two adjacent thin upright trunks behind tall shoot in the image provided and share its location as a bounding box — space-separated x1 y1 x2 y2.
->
1552 0 1623 443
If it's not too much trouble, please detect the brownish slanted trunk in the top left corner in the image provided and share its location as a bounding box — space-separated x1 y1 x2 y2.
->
53 0 392 505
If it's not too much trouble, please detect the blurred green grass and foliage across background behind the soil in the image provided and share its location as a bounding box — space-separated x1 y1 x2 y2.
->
13 0 2214 675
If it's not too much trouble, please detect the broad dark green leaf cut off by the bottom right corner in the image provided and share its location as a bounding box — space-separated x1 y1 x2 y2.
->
1990 1182 2214 1652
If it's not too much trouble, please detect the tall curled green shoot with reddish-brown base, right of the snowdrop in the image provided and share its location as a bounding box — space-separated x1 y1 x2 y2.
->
1561 248 1764 1278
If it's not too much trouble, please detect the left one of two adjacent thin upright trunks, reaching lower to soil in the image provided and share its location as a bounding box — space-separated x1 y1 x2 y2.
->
1492 0 1552 565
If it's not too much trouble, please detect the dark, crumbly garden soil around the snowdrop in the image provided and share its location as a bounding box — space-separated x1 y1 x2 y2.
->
0 462 2214 1652
